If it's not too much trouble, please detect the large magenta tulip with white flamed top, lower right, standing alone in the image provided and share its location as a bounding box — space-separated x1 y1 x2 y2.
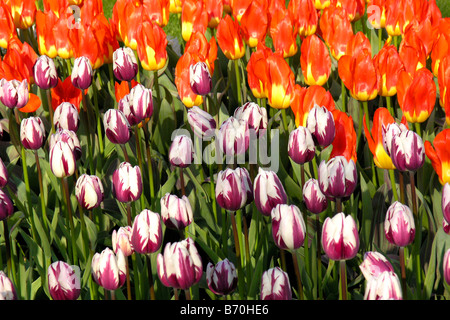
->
322 212 359 261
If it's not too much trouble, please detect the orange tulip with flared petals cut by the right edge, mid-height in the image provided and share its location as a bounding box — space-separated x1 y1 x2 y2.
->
424 129 450 185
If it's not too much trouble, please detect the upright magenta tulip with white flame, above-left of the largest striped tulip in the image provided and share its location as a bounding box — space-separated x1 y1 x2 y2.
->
131 209 162 254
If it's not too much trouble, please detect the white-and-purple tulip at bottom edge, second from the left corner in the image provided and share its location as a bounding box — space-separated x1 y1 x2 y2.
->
47 261 81 300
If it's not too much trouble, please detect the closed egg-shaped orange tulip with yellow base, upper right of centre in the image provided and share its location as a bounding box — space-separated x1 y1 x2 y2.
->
300 34 331 86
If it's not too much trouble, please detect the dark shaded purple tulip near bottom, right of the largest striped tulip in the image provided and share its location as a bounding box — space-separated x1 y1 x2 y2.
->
206 259 237 295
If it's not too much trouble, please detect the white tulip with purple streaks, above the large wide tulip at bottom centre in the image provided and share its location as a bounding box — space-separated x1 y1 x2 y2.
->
161 193 194 230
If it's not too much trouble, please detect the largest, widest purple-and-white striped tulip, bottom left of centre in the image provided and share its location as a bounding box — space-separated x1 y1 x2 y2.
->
156 238 203 290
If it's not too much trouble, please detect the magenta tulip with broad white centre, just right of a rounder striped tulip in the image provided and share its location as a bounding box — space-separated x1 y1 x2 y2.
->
112 162 142 202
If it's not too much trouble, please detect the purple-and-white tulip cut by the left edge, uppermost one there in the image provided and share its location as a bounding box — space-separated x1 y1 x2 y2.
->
0 79 29 109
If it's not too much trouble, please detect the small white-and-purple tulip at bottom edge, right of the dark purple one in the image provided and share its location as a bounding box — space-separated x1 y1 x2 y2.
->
260 267 292 300
